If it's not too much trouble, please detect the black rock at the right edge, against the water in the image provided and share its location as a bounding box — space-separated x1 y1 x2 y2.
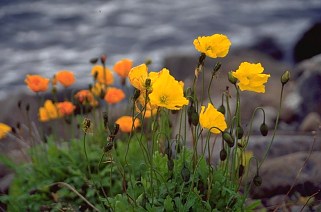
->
293 22 321 62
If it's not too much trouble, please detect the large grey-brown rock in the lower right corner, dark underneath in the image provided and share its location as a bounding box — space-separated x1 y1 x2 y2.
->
251 151 321 200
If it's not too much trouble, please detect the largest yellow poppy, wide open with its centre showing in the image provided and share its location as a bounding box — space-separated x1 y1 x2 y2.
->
149 68 188 110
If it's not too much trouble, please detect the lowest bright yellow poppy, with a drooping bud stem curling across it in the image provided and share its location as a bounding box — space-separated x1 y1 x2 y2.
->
199 103 227 134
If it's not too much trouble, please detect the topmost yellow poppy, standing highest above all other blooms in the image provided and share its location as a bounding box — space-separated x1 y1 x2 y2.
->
193 34 231 58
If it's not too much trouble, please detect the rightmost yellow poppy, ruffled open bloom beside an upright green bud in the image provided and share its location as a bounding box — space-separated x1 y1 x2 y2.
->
232 62 270 93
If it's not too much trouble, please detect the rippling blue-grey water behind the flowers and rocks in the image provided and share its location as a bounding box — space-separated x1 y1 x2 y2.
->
0 0 321 98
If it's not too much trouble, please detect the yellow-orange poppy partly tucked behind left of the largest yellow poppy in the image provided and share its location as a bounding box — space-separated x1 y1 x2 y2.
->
128 64 158 91
